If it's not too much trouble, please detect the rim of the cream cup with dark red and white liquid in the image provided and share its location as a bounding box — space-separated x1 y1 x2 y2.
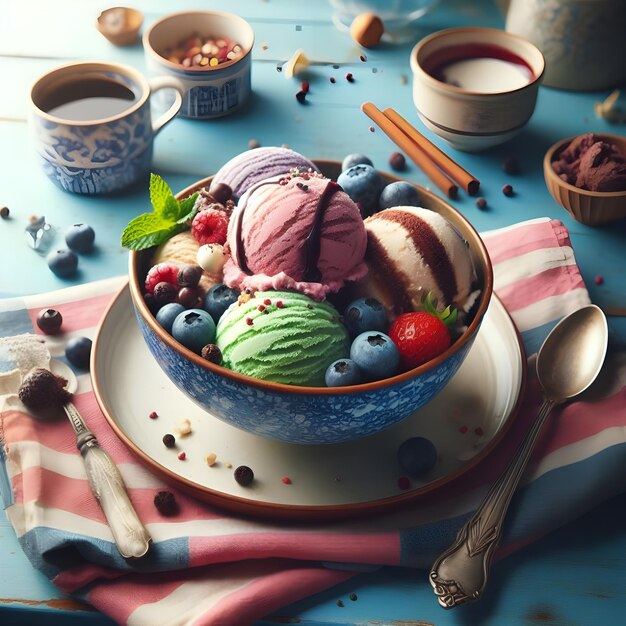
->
409 26 546 98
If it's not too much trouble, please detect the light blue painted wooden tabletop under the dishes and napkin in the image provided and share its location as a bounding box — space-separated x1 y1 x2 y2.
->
0 0 626 626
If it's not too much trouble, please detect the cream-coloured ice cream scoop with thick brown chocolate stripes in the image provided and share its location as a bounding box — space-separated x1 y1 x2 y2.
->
359 206 475 318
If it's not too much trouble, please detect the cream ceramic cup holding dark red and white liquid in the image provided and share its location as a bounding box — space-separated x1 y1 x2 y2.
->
410 27 545 152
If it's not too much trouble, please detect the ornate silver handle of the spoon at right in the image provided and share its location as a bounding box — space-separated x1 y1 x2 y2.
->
429 399 557 609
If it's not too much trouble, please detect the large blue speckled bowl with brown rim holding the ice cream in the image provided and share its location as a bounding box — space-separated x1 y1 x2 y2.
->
129 161 493 444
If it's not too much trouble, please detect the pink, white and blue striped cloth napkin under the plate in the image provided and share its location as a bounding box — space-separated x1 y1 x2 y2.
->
0 218 626 626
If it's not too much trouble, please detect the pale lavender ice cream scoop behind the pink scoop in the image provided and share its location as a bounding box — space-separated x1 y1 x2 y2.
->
209 146 318 201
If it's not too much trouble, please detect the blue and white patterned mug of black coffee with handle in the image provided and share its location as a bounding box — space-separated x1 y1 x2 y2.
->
30 63 183 194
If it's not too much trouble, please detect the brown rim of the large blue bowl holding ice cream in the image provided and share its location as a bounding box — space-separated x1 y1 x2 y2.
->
128 159 493 396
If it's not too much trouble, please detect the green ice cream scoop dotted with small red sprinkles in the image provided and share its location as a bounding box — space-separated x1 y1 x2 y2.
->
216 291 349 386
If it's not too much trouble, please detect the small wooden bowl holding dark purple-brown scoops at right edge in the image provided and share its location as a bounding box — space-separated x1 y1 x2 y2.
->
543 133 626 226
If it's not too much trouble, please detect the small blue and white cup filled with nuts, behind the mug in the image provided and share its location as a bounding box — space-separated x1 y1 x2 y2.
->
143 11 254 120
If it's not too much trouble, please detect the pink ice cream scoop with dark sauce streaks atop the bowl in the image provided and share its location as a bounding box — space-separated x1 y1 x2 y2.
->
224 174 367 300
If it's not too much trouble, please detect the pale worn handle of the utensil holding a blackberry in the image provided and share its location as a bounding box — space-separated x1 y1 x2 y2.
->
63 402 151 558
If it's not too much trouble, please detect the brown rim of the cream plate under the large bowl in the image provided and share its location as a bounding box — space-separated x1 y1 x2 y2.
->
91 281 527 522
